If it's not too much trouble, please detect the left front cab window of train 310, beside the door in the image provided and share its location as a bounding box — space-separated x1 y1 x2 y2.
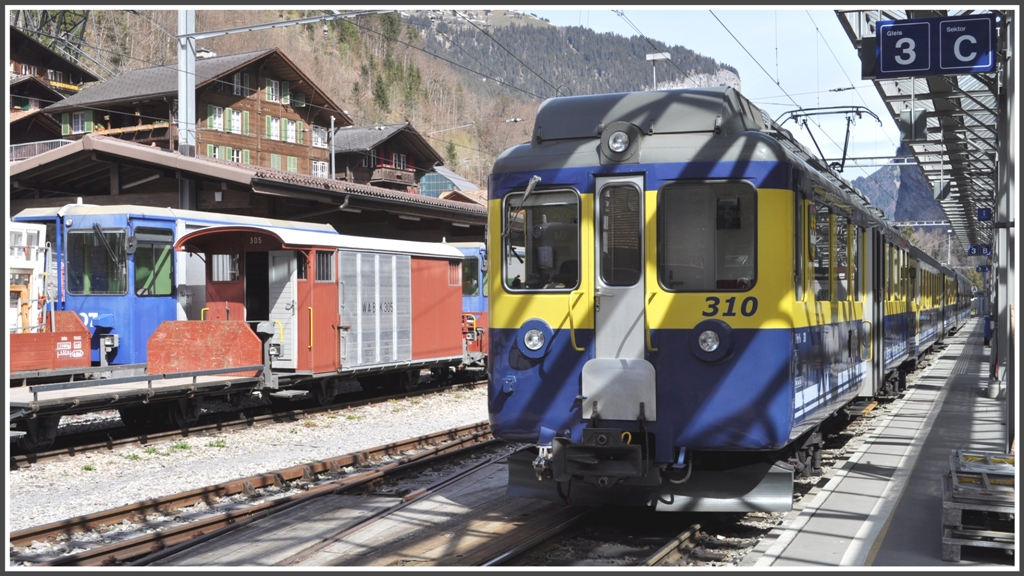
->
502 191 580 290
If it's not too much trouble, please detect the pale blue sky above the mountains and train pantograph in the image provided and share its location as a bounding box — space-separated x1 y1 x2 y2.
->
532 4 899 179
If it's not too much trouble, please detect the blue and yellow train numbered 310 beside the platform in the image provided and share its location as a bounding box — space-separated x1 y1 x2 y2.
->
487 87 970 511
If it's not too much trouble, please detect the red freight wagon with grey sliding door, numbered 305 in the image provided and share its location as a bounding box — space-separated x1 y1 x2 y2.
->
148 225 463 387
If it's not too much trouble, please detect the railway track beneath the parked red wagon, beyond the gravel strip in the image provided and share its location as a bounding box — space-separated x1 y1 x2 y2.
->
10 380 486 469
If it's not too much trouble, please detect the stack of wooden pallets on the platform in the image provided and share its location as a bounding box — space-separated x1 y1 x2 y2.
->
942 449 1015 562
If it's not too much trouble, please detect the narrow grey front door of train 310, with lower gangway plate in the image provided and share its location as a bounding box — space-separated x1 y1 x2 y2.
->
583 176 655 420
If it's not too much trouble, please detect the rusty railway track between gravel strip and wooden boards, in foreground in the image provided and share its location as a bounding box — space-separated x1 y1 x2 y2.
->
9 422 493 566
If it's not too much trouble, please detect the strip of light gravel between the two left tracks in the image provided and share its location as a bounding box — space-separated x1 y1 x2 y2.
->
6 385 487 534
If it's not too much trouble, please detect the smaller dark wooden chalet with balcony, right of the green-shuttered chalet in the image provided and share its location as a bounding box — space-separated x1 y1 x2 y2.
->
334 122 442 194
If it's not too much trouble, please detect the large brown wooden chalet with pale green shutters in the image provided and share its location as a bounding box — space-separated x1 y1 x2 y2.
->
44 48 352 177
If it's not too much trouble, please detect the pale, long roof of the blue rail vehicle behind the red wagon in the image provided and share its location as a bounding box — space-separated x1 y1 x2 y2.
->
11 204 335 233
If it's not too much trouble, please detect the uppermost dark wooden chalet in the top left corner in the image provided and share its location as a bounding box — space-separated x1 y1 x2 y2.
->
8 26 99 97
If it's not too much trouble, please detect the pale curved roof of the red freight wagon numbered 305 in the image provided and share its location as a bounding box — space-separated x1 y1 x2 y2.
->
174 224 463 259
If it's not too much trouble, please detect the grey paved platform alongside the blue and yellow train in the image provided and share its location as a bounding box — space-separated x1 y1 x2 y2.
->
755 319 1018 569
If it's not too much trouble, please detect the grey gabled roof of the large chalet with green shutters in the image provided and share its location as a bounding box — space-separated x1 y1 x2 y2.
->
46 48 352 124
